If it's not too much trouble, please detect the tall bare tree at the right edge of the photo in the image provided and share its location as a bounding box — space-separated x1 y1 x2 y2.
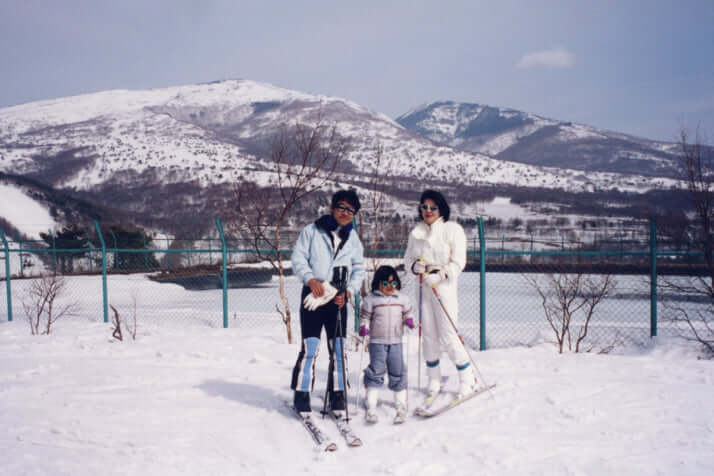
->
663 129 714 355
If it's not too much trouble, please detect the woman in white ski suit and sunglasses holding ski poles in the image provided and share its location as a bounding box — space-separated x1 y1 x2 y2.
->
404 190 475 401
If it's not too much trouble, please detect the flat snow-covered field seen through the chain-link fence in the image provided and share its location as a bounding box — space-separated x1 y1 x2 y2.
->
0 270 656 350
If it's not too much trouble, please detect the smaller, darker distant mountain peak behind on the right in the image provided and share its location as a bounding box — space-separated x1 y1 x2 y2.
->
396 101 679 177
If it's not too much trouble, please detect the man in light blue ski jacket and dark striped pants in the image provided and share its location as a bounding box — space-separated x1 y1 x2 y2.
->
291 190 364 412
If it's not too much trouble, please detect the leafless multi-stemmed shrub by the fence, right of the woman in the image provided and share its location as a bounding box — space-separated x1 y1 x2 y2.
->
524 273 616 354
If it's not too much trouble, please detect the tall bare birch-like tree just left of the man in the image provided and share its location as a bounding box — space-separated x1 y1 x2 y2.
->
232 114 348 343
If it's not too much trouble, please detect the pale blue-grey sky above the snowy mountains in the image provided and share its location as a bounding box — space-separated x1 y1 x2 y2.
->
0 0 714 140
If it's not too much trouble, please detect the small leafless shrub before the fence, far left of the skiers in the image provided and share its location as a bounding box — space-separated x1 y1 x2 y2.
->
22 274 78 335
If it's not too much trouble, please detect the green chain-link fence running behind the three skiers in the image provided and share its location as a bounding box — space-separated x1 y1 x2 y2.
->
0 220 712 351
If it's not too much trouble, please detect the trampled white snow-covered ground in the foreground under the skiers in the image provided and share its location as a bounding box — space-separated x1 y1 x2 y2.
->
0 277 714 476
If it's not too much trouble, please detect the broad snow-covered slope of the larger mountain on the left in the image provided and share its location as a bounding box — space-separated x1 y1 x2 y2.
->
0 80 671 197
